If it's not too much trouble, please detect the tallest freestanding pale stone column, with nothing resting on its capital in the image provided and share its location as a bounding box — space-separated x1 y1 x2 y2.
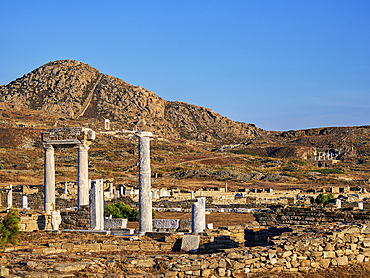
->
136 132 153 234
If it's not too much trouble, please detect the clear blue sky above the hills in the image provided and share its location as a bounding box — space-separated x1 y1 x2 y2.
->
0 0 370 130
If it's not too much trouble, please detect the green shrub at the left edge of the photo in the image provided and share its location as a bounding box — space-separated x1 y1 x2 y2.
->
0 209 22 248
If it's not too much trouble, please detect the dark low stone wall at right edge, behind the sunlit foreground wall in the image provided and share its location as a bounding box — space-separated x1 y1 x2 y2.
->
253 206 370 226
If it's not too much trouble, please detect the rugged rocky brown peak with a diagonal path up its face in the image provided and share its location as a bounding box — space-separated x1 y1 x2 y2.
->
0 60 268 143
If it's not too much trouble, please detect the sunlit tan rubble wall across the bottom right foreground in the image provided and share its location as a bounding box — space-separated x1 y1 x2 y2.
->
119 226 370 277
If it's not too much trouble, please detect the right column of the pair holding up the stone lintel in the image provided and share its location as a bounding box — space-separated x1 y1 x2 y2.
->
75 141 89 208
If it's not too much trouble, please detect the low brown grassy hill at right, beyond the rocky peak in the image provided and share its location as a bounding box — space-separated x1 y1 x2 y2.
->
238 126 370 166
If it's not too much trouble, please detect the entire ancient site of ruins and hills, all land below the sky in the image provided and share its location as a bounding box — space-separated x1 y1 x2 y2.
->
0 60 370 278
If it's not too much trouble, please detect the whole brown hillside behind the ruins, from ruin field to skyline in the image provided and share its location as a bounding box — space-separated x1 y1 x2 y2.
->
0 60 370 190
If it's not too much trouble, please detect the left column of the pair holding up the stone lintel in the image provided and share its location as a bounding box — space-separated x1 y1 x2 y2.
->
44 144 55 214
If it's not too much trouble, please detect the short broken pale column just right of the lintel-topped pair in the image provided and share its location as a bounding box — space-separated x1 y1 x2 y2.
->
90 179 104 230
